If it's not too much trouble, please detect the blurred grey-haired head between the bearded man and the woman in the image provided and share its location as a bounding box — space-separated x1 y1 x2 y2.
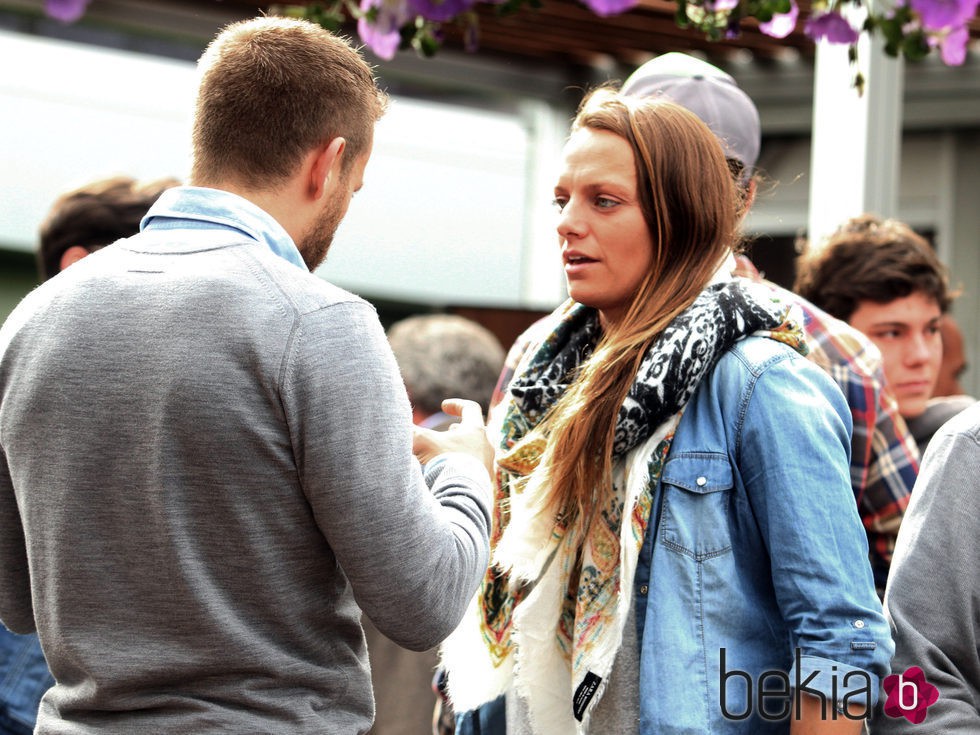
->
388 314 505 429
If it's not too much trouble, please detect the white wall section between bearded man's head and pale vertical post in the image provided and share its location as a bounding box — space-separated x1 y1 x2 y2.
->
321 99 528 306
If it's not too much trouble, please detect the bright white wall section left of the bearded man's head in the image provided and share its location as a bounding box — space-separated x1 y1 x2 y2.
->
0 31 194 250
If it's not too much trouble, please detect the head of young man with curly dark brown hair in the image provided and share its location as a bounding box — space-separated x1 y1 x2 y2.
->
794 215 953 419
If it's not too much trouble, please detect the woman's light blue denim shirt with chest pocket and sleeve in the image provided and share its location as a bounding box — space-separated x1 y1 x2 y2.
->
634 337 894 735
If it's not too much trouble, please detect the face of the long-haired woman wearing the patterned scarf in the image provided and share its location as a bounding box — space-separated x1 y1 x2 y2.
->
555 128 653 324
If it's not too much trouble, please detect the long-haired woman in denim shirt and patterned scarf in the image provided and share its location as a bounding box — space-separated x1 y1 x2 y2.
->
442 89 893 735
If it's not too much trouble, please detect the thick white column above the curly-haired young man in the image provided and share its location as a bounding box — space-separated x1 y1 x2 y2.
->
807 9 904 248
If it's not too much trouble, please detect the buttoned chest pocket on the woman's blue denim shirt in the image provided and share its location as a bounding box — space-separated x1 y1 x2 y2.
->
659 453 734 562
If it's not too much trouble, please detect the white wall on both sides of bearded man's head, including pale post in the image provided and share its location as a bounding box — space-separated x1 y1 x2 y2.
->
0 31 561 308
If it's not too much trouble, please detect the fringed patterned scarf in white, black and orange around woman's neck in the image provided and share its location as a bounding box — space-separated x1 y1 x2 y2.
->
443 281 806 733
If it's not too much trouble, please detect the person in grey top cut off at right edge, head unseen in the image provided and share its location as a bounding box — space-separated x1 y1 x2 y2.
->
871 404 980 735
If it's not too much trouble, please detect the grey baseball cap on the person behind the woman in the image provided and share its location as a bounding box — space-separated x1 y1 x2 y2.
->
622 52 762 180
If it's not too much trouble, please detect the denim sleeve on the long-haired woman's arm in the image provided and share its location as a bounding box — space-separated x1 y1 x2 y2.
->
735 344 894 702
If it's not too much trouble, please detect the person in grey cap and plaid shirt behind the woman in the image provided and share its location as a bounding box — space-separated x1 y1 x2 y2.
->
622 53 919 593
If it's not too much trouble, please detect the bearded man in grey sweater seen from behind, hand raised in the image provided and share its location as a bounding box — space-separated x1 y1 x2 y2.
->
0 18 490 735
